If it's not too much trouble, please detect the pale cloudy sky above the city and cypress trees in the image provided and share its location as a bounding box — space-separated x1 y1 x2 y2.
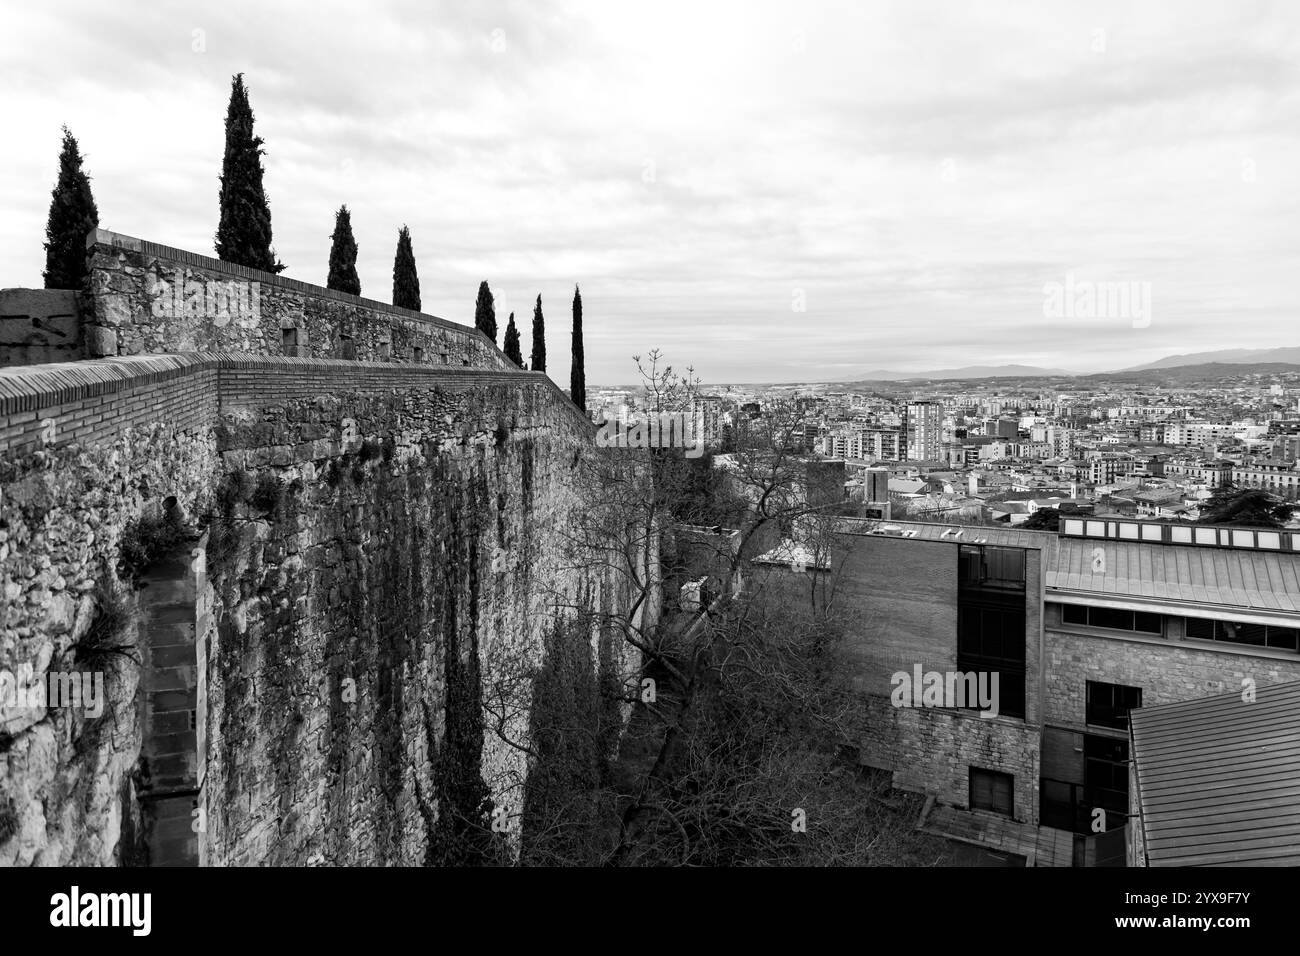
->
0 0 1300 384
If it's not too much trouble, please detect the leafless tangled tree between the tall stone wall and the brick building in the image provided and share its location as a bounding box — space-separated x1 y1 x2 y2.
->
485 351 941 865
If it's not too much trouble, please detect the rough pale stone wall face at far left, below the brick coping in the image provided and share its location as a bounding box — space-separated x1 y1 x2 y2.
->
0 423 218 866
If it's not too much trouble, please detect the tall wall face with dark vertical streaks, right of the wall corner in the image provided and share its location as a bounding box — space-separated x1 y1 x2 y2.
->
203 386 608 865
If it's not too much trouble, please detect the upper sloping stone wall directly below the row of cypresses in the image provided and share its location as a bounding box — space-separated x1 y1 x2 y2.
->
82 229 512 369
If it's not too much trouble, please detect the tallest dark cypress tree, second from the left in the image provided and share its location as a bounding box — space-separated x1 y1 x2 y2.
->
217 73 285 272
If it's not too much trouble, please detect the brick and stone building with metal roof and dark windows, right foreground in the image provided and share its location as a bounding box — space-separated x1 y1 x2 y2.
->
772 516 1300 865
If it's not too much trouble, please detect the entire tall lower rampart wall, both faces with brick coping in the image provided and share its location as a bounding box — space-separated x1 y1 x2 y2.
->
0 354 621 865
